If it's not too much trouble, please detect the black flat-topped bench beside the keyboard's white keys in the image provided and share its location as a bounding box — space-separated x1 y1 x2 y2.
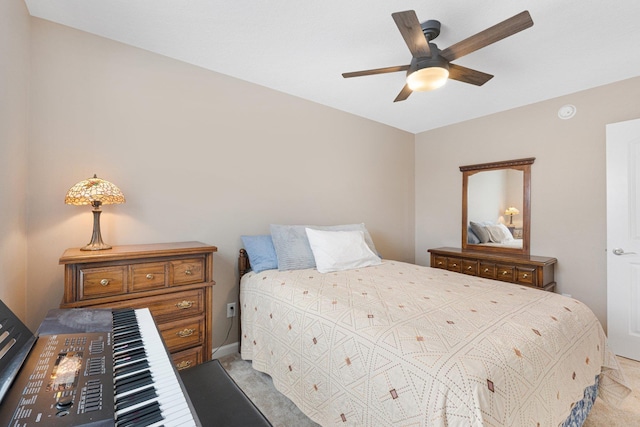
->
179 359 271 427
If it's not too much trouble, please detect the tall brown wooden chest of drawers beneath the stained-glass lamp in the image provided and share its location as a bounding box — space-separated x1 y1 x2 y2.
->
60 242 218 369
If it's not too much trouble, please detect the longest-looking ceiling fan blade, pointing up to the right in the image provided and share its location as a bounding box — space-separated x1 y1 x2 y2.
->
440 10 533 61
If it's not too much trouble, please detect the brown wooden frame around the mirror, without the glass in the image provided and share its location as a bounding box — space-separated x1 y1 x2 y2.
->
460 157 535 255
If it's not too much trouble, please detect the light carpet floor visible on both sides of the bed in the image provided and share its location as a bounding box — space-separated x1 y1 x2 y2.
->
220 353 640 427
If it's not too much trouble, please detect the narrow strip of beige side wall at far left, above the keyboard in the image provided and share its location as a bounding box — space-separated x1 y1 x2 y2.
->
0 0 30 320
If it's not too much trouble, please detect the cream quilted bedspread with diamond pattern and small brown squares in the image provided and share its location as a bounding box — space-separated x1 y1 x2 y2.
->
240 261 630 427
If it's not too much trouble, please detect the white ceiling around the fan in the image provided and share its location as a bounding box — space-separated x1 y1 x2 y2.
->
25 0 640 133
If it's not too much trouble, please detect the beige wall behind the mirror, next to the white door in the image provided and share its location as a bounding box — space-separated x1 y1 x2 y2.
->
415 78 640 332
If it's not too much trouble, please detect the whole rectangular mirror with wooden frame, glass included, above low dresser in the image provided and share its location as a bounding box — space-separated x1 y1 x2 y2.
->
460 157 535 255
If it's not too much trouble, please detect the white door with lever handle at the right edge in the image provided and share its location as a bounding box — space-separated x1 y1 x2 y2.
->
607 119 640 360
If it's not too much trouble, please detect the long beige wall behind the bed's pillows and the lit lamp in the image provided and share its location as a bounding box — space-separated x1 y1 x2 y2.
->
28 19 415 346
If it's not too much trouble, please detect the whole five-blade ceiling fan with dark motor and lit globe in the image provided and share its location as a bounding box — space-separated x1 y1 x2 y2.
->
342 10 533 102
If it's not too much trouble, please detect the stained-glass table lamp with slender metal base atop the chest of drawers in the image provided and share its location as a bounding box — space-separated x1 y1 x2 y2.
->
64 175 125 251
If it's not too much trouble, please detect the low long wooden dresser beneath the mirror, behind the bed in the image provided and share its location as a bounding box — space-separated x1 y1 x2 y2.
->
429 248 558 291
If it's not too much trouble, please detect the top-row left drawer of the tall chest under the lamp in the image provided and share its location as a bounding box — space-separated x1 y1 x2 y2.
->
78 266 127 300
